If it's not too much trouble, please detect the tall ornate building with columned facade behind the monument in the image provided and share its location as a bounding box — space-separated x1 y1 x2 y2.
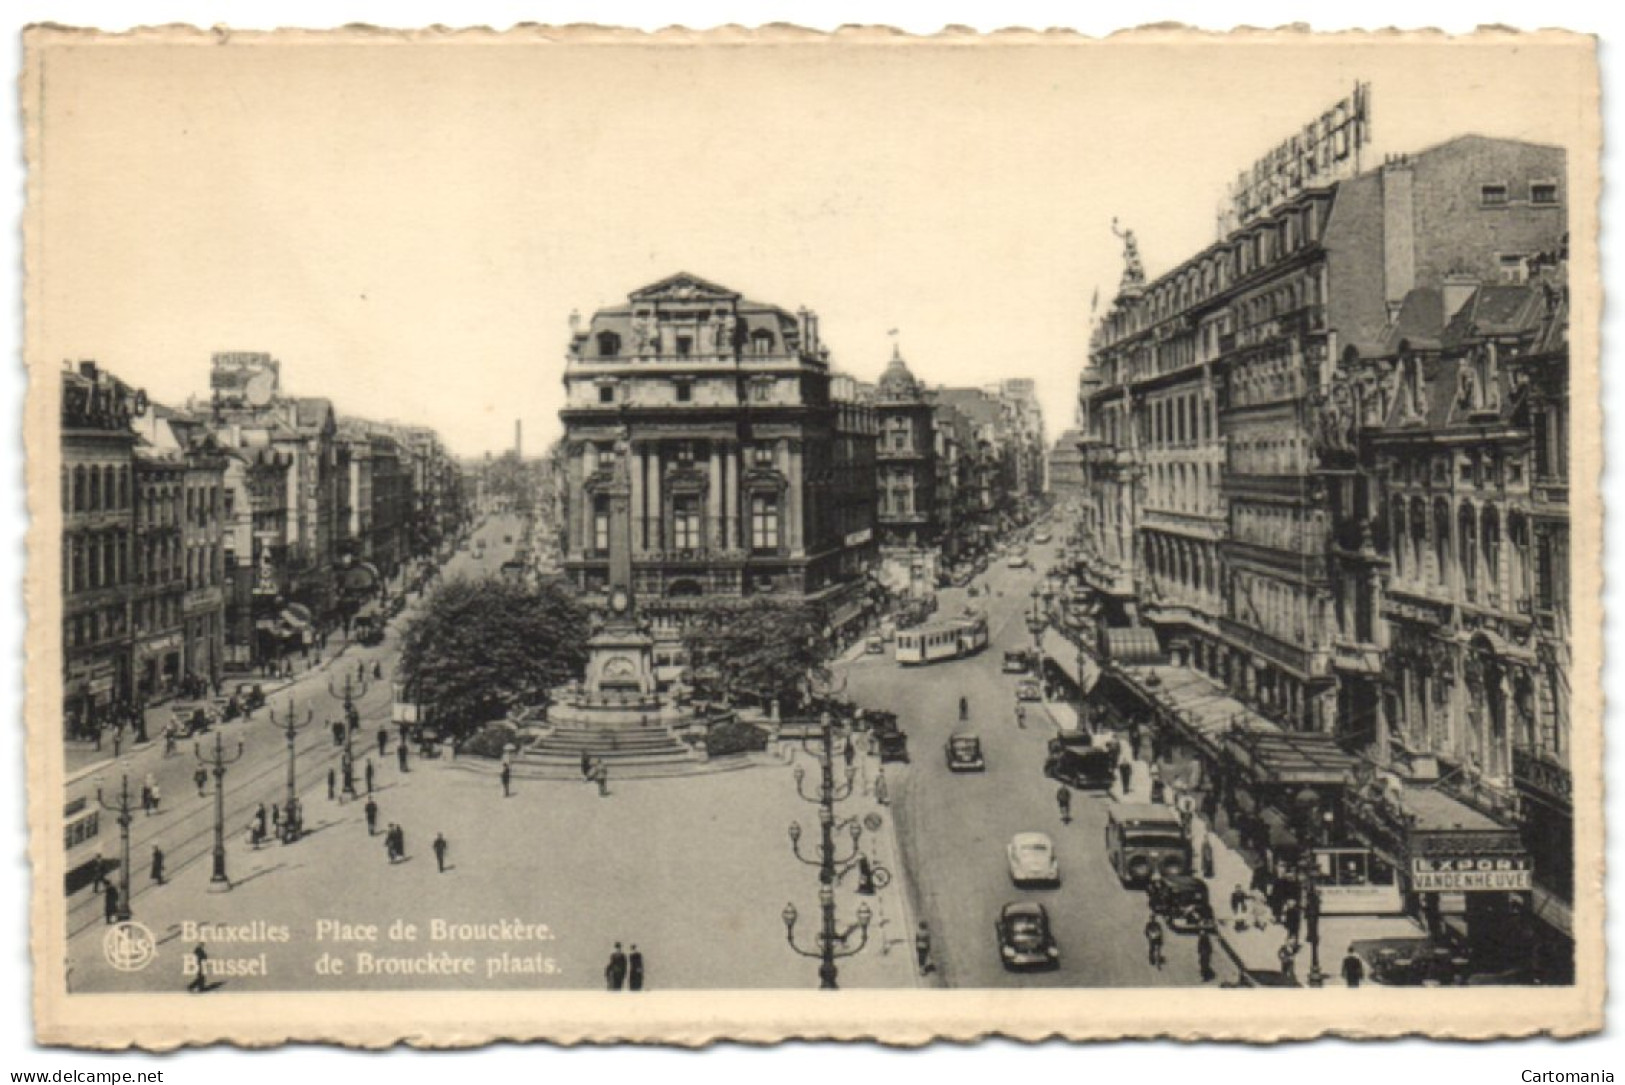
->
561 273 874 620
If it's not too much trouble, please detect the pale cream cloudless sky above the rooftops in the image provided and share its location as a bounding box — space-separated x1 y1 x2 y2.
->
28 30 1586 455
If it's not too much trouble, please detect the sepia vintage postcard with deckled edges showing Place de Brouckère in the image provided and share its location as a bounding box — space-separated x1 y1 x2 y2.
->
23 28 1604 1049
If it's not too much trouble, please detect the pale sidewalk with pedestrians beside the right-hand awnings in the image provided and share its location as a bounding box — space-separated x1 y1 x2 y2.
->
1110 734 1422 988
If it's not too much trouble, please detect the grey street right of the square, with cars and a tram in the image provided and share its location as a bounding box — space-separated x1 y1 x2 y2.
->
845 546 1235 988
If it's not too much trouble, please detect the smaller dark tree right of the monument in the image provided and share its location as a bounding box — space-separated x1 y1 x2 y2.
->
684 598 829 705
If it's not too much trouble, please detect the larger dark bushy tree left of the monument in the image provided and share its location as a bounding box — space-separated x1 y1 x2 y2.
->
401 577 588 734
